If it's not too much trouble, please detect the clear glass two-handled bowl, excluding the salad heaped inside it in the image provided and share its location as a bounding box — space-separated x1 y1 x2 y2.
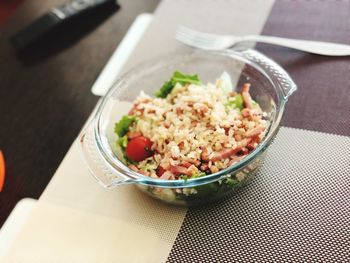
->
80 50 297 205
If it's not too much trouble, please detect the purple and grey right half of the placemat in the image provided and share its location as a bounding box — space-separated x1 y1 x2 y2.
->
168 0 350 262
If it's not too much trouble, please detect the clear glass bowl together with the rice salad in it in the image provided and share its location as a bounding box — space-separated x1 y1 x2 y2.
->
81 50 296 205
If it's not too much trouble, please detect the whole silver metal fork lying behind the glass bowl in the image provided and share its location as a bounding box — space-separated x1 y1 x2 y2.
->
176 26 350 56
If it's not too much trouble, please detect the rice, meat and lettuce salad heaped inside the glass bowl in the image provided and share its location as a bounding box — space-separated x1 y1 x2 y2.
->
115 71 268 185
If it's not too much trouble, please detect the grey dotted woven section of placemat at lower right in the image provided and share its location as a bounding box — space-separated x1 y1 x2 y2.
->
168 128 350 262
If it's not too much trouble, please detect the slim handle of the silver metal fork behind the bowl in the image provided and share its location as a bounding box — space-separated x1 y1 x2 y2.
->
238 35 350 56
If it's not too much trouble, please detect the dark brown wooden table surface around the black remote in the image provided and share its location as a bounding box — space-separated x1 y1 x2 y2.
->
0 0 159 226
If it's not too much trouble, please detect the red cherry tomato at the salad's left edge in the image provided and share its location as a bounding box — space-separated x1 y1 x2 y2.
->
126 136 153 162
